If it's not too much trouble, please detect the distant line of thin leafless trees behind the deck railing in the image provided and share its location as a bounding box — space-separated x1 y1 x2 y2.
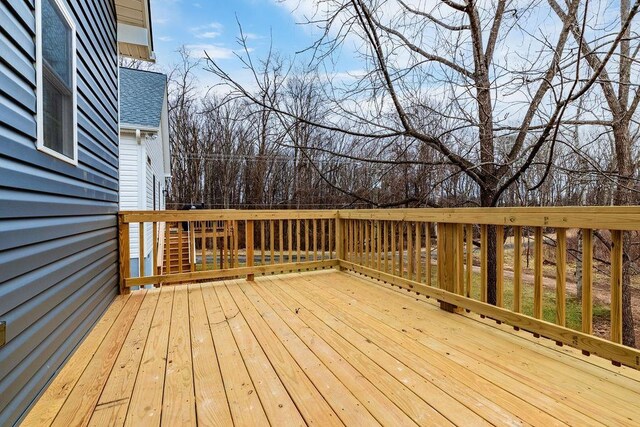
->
167 53 638 209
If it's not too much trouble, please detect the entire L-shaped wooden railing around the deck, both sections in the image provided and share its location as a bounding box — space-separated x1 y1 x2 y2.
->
120 207 640 368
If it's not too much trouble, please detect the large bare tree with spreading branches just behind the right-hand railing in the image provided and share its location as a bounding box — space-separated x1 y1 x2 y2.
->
207 0 632 303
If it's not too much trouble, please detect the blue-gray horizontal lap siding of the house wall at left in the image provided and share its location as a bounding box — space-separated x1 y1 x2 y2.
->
0 0 118 426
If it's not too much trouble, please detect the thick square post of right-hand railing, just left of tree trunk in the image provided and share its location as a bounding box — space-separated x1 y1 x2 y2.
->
438 223 462 313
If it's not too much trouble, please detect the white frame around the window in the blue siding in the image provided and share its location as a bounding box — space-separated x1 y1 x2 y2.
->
35 0 78 166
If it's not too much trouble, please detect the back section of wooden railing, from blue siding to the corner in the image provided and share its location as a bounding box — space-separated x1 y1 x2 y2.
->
119 210 338 292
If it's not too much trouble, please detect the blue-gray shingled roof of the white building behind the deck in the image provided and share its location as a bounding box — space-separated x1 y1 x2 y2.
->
120 67 167 127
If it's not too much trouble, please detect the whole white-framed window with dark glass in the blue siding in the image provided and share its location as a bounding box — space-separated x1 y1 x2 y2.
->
36 0 78 164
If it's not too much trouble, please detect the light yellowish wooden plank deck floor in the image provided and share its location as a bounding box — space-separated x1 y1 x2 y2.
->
24 270 640 427
